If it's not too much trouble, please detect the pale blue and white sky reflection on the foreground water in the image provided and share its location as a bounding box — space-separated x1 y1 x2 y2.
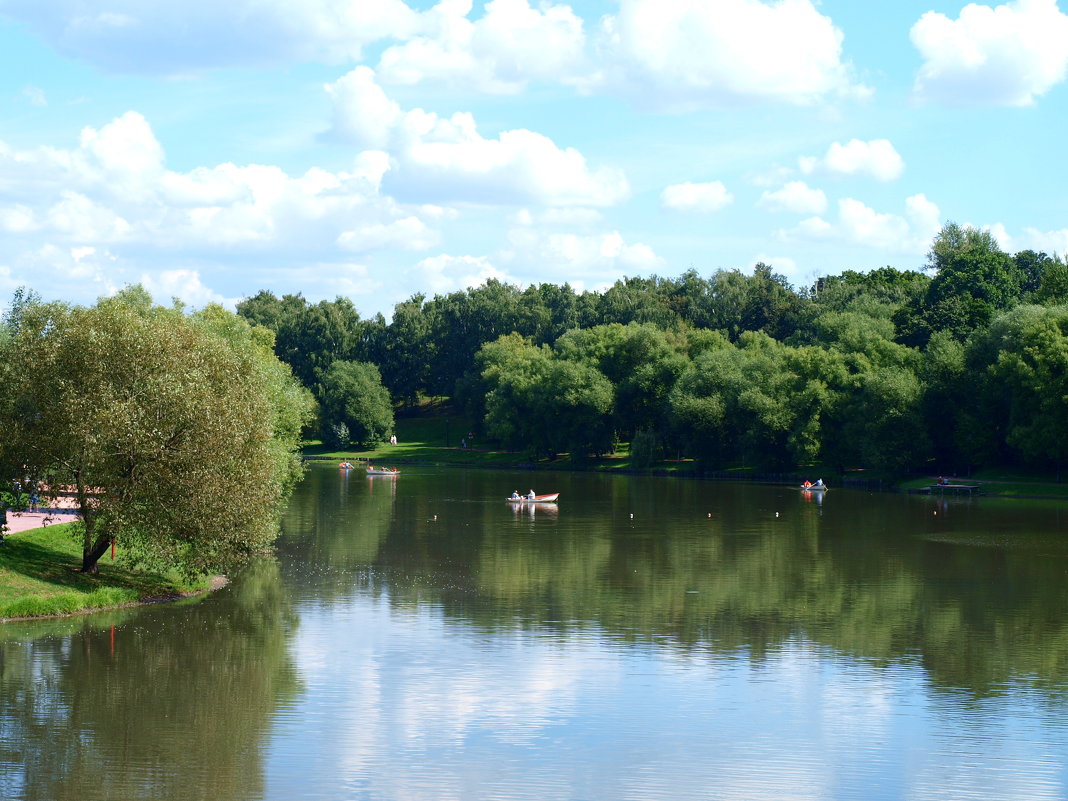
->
266 596 1068 801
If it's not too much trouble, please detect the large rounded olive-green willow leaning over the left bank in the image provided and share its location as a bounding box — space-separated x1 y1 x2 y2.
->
0 287 309 574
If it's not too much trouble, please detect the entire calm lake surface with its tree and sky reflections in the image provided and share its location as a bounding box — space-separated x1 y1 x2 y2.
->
6 467 1068 801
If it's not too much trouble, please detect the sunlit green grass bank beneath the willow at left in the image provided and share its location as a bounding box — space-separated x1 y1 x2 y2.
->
0 523 209 619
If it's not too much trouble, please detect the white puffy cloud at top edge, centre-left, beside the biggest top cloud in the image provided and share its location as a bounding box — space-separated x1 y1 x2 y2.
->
378 0 585 94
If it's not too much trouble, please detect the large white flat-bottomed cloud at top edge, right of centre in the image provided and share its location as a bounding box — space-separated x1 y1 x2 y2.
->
587 0 869 108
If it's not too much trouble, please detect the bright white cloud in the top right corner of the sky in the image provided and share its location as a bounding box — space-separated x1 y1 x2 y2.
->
909 0 1068 106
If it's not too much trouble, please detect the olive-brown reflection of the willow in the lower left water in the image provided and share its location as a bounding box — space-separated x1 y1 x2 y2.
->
0 562 298 801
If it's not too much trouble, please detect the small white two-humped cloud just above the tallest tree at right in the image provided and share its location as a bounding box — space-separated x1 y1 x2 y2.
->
780 194 941 253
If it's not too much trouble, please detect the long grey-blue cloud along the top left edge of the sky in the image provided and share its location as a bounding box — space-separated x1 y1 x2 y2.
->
2 0 424 75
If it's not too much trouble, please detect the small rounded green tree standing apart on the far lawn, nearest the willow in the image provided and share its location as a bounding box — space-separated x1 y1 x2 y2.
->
319 361 393 447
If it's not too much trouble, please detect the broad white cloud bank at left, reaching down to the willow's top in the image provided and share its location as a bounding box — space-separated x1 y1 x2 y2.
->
0 107 454 305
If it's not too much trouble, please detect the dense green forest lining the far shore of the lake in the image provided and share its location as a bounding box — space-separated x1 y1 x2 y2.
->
238 223 1068 472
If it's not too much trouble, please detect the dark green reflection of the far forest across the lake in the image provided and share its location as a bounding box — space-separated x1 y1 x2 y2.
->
281 472 1068 695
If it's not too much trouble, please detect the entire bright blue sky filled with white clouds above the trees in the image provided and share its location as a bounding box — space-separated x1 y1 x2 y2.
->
0 0 1068 318
